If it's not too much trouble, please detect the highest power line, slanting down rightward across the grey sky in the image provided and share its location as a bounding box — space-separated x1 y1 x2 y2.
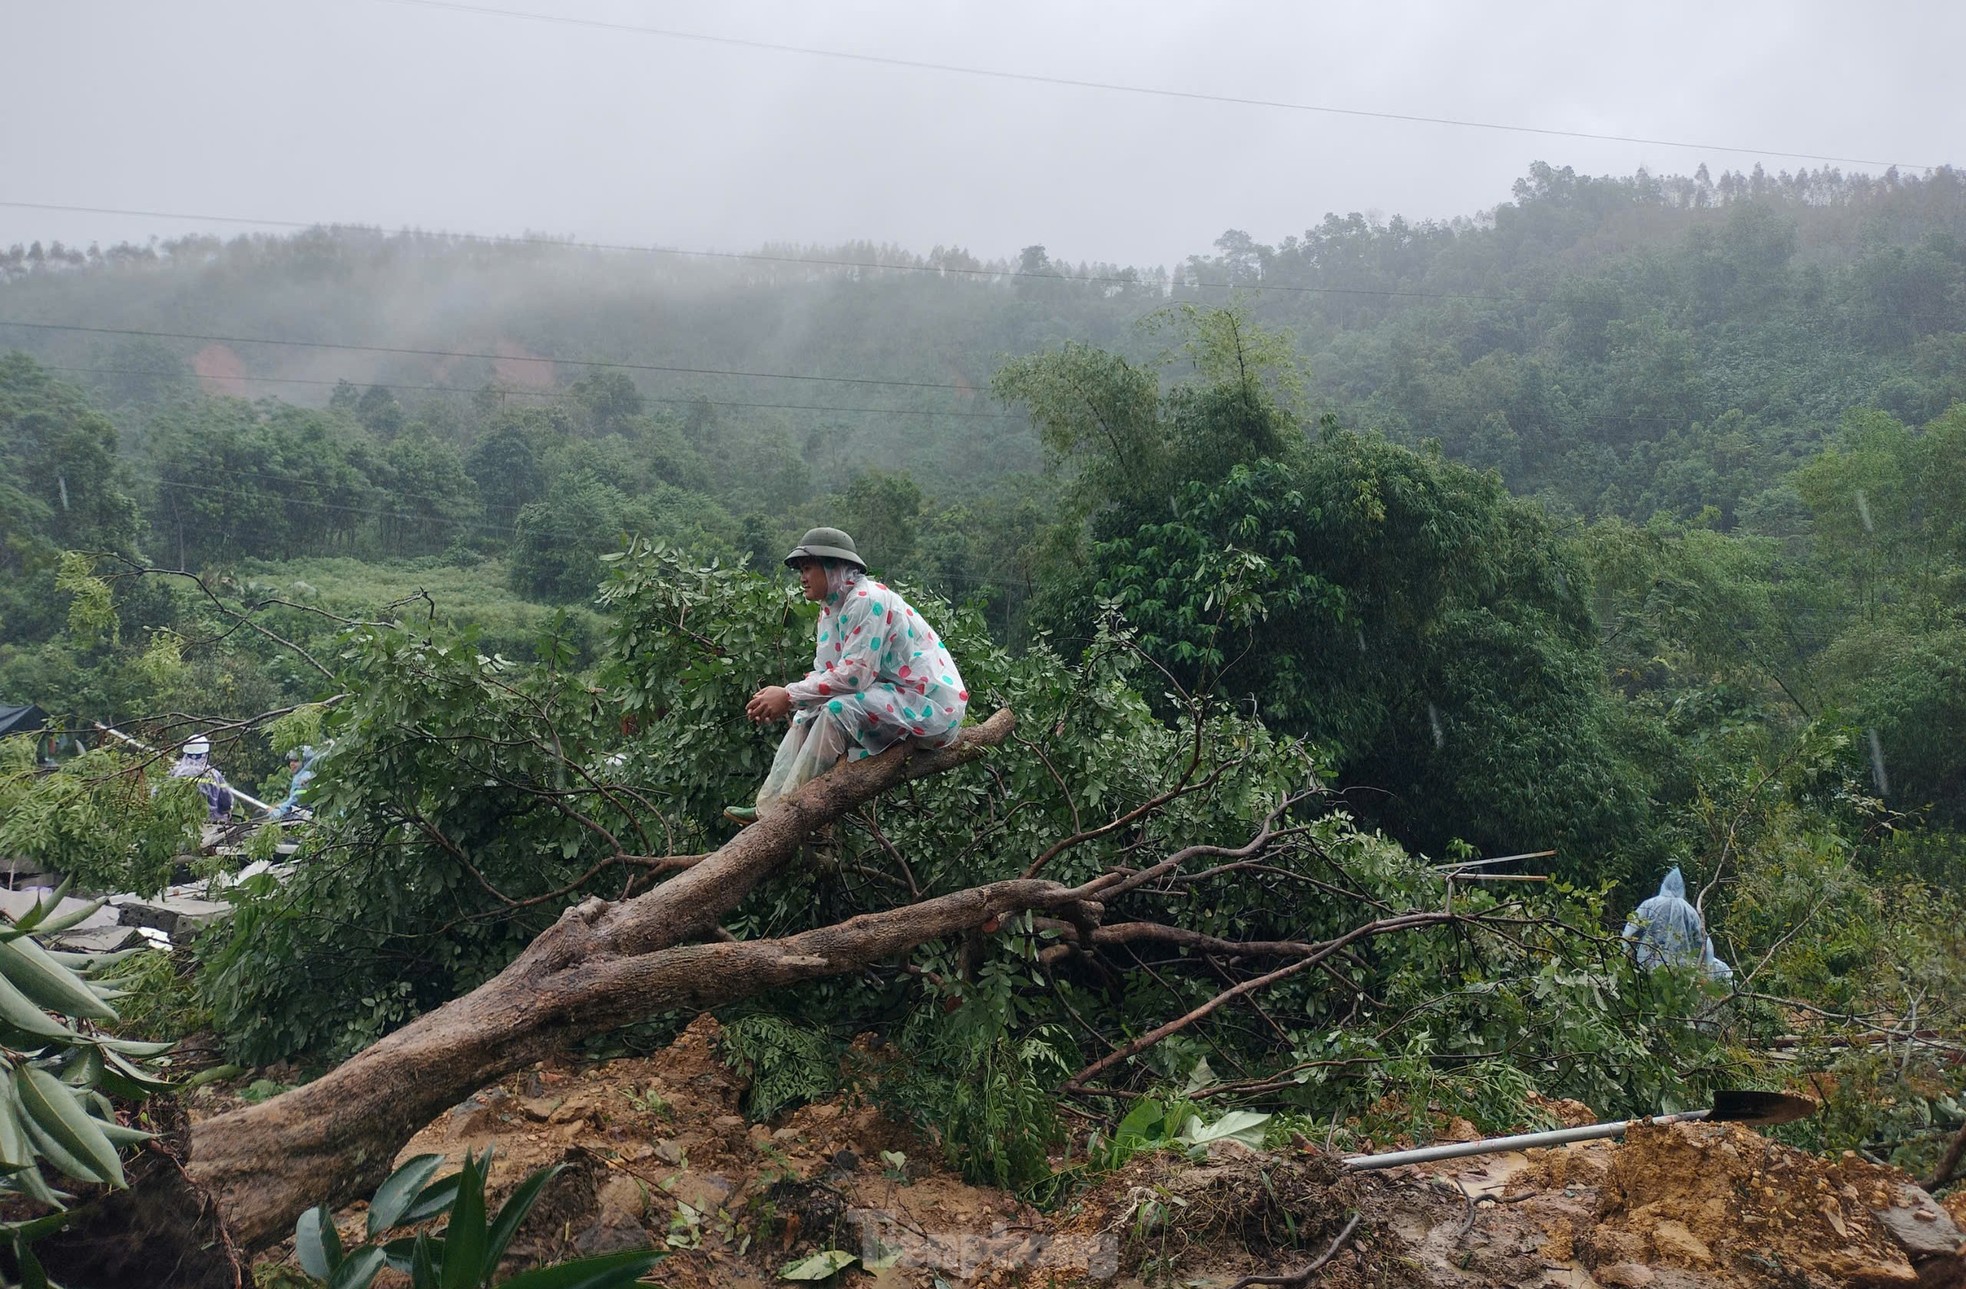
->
371 0 1937 171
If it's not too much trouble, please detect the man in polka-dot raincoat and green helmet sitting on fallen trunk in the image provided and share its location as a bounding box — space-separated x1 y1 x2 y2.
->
723 529 969 823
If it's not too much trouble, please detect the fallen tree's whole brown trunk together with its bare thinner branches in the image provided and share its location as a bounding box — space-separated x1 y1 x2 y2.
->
157 709 1612 1250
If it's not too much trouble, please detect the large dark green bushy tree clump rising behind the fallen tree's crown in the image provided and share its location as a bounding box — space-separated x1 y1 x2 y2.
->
999 312 1653 876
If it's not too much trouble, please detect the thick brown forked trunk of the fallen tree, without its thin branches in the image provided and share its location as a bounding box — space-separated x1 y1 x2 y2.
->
185 711 1014 1248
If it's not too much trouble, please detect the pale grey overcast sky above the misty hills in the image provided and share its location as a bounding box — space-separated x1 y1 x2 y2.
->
0 0 1966 263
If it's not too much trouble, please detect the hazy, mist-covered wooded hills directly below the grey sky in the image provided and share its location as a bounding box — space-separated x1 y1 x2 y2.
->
11 165 1966 527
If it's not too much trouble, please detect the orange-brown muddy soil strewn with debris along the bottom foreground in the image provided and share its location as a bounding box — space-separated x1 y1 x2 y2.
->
207 1016 1966 1289
